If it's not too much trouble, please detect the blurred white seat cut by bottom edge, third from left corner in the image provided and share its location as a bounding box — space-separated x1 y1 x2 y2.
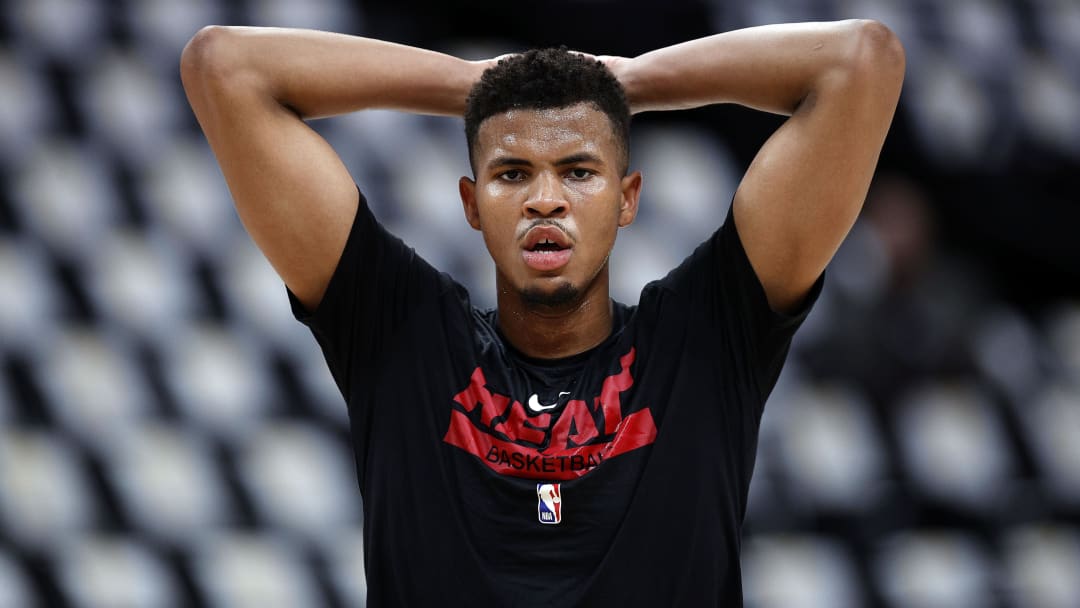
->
192 532 322 608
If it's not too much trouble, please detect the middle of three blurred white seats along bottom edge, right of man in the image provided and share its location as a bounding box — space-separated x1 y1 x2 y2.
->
873 531 994 608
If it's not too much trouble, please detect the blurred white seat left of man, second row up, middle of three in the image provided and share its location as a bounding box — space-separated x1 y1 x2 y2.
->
106 422 234 545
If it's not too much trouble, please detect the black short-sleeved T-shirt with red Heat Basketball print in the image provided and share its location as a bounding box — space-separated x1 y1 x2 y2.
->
292 192 821 607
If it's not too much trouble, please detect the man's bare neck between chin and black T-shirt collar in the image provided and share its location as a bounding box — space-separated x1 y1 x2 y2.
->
498 285 611 359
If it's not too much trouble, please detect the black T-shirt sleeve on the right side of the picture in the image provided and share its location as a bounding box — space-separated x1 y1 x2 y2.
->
664 201 824 405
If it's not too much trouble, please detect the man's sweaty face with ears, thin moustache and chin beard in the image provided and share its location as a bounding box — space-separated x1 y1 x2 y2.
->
460 104 642 307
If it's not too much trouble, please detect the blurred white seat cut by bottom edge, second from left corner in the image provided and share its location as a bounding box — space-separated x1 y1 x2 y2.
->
56 535 180 608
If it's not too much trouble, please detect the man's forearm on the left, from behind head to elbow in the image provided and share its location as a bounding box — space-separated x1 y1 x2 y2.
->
181 26 486 118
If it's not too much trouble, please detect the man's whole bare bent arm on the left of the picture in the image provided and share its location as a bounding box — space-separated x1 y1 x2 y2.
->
180 26 487 311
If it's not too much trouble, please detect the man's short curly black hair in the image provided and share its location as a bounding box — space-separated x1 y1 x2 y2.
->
464 46 630 176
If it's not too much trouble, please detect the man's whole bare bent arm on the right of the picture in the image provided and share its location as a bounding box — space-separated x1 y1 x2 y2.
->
608 21 904 311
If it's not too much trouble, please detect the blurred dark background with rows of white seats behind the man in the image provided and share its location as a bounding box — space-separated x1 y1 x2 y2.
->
0 0 1080 608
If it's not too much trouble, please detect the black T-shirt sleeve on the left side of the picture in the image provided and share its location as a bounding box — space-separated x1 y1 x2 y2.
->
288 187 449 400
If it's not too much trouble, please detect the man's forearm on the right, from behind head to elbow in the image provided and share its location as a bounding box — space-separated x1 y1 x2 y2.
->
615 21 903 114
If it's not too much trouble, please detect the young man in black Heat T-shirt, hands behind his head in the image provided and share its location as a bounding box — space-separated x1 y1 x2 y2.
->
181 17 904 606
